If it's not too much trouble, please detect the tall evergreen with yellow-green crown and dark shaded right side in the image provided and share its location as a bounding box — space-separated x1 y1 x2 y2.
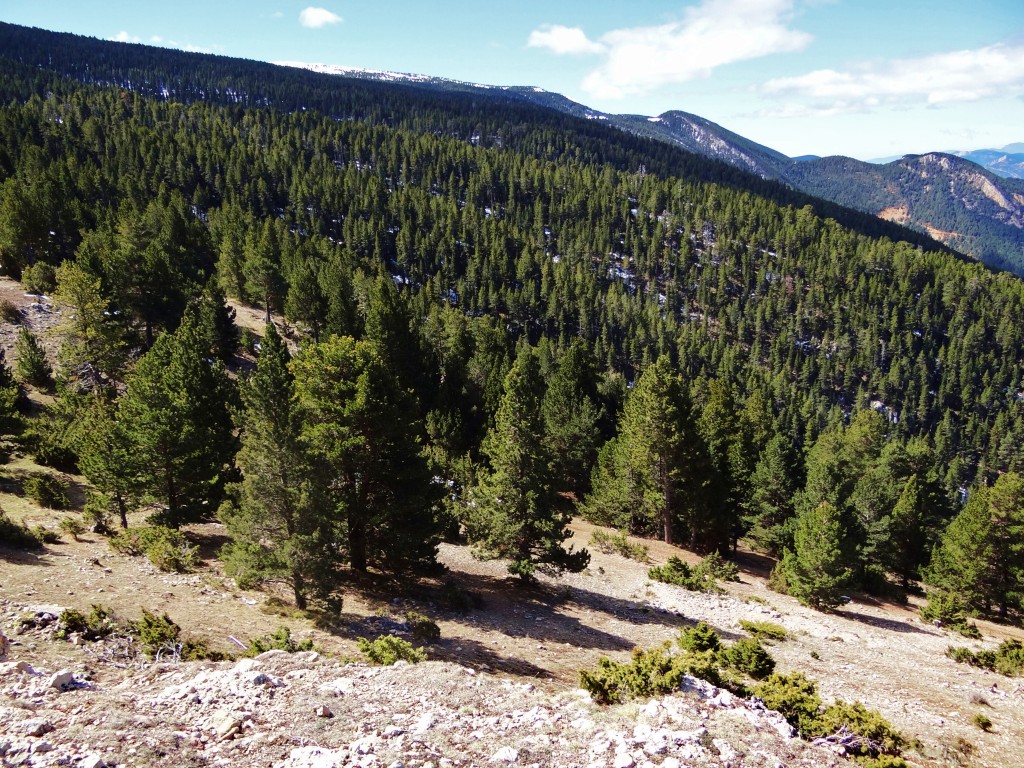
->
292 336 437 571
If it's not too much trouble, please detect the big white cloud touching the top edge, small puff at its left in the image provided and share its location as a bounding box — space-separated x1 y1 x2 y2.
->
528 0 811 98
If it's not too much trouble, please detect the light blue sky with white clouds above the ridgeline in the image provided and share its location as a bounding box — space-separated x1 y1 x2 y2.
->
0 0 1024 160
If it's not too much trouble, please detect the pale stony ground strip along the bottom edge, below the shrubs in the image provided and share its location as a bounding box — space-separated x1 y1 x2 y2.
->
0 618 847 768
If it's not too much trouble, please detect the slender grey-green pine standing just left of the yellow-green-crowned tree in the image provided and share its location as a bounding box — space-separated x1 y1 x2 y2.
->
224 326 340 608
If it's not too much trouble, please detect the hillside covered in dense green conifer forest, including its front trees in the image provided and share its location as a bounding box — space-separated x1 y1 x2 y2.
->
6 28 1024 626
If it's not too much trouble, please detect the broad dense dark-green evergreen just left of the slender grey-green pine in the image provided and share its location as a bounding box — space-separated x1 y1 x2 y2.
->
117 312 236 526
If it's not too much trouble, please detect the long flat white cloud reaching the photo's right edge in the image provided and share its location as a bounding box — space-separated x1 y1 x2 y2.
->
761 44 1024 111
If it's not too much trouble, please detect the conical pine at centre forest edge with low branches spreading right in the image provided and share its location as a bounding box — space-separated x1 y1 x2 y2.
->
464 344 590 581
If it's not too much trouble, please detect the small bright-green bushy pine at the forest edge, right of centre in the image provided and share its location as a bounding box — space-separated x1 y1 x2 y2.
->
782 502 850 608
